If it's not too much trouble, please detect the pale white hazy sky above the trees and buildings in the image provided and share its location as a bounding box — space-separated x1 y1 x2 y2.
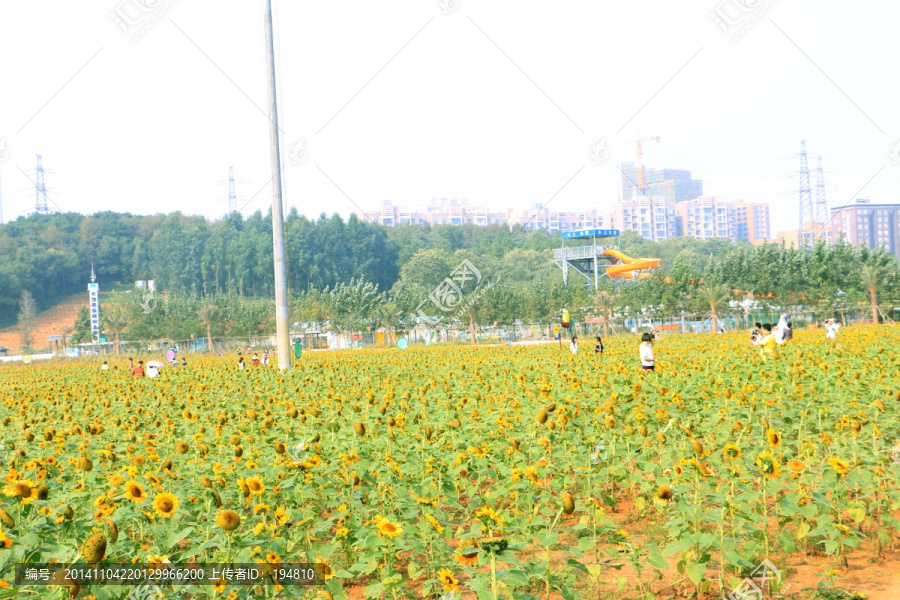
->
0 0 900 233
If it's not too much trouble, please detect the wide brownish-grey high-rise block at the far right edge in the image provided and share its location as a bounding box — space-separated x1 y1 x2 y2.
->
830 199 900 258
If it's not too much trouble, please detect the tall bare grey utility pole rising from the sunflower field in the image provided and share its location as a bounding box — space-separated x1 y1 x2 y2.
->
266 0 291 371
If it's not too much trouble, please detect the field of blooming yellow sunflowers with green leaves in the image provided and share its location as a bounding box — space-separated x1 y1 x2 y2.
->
0 326 900 600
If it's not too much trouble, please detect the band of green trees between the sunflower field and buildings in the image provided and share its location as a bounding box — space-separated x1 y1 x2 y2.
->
0 211 900 341
